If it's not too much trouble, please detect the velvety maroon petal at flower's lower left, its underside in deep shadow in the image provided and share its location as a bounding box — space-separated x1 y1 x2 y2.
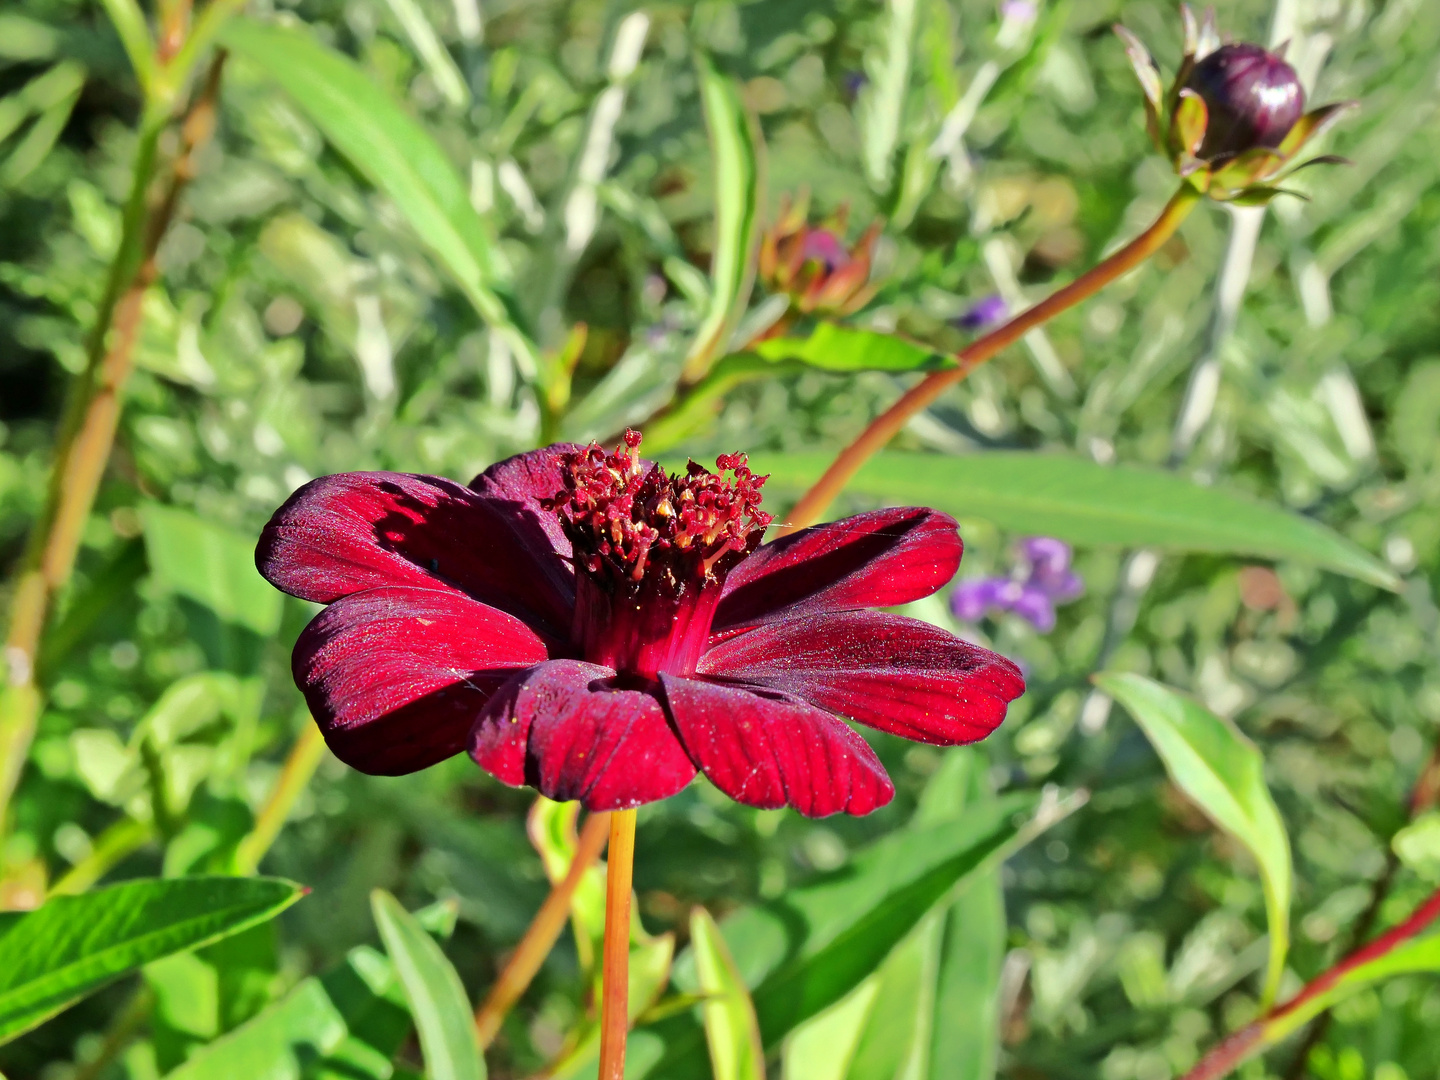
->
292 588 546 776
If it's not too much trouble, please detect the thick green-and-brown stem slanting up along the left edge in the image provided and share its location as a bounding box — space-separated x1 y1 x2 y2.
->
0 53 225 827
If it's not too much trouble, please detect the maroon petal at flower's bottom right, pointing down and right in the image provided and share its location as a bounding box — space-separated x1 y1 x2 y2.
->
660 675 896 818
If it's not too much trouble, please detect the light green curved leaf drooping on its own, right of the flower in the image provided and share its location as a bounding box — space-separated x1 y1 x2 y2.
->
1094 672 1292 1004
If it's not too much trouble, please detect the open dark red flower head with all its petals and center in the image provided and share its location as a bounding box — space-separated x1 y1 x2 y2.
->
255 432 1024 816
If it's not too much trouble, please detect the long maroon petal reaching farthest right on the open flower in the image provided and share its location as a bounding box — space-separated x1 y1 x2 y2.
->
698 612 1025 746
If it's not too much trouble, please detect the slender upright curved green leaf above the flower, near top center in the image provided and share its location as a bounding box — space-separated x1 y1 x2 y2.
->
684 53 760 382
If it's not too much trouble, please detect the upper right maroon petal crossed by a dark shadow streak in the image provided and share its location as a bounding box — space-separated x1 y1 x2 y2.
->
714 507 962 635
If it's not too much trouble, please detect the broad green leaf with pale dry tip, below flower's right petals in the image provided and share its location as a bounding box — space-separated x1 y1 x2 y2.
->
654 793 1068 1080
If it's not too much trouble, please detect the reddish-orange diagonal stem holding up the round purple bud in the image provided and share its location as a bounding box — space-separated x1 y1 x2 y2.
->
779 183 1202 536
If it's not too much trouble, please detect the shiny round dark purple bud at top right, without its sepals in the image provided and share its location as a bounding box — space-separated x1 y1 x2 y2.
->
1185 45 1305 160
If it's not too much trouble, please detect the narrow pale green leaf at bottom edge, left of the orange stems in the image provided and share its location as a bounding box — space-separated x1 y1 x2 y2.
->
370 888 485 1080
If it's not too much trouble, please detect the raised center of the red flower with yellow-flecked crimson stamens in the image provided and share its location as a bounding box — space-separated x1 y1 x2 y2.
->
546 431 770 678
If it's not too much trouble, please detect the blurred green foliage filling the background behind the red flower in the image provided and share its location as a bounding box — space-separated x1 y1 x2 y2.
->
0 0 1440 1080
